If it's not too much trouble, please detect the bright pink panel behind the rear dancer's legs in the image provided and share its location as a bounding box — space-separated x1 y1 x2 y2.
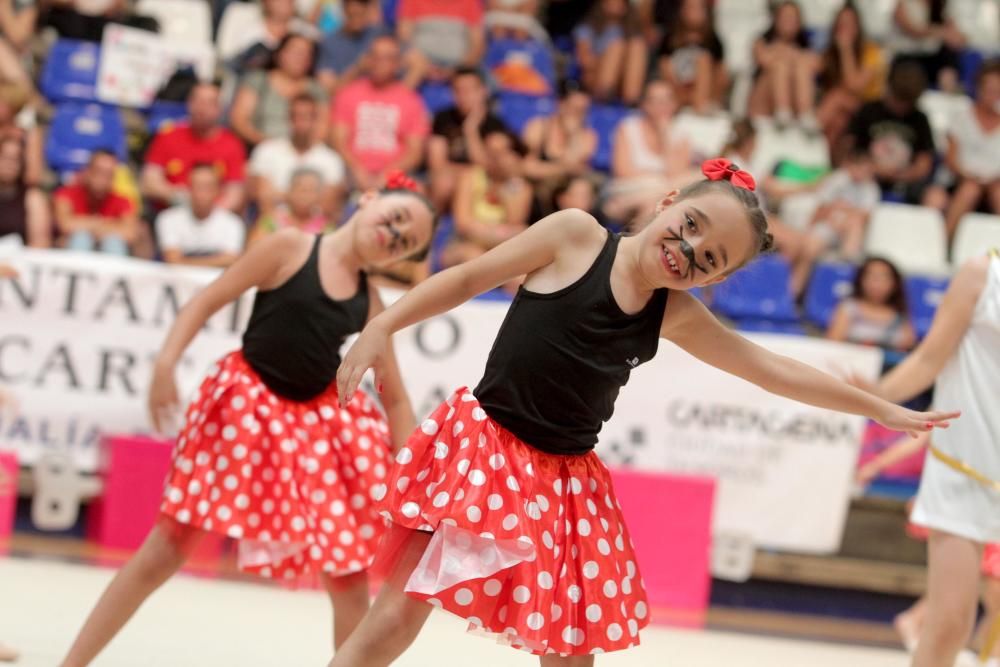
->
87 435 225 572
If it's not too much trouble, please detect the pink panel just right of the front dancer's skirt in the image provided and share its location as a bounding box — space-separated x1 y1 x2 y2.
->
612 468 715 627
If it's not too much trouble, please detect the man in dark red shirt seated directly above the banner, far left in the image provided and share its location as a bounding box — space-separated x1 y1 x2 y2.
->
55 150 141 255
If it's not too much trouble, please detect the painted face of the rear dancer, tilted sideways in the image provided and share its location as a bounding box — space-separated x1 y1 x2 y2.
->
354 193 433 266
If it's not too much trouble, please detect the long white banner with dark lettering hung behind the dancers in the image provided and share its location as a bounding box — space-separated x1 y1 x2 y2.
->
0 250 881 553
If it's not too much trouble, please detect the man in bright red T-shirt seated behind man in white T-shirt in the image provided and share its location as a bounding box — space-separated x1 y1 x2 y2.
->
142 83 247 213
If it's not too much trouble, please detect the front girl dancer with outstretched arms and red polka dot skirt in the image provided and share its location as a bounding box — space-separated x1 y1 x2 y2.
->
332 160 956 667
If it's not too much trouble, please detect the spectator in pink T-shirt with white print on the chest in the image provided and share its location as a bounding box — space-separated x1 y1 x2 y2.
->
331 35 430 189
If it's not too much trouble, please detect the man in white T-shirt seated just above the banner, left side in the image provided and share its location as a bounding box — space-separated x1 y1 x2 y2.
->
156 164 246 267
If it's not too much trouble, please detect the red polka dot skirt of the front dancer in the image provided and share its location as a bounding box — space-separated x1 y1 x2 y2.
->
374 388 649 655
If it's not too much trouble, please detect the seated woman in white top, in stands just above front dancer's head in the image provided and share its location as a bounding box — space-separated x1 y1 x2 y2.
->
604 81 700 222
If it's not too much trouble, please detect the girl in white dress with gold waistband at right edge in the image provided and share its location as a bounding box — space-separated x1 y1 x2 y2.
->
855 251 1000 667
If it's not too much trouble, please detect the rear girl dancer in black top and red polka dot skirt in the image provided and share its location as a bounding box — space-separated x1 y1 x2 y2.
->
63 177 434 666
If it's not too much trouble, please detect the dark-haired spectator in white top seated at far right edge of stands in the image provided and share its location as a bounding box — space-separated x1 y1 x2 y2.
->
924 60 1000 238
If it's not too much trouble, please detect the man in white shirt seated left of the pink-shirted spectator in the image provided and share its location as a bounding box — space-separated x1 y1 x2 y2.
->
250 95 346 220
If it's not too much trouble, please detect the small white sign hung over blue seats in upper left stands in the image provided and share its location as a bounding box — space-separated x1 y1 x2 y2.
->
97 23 215 107
